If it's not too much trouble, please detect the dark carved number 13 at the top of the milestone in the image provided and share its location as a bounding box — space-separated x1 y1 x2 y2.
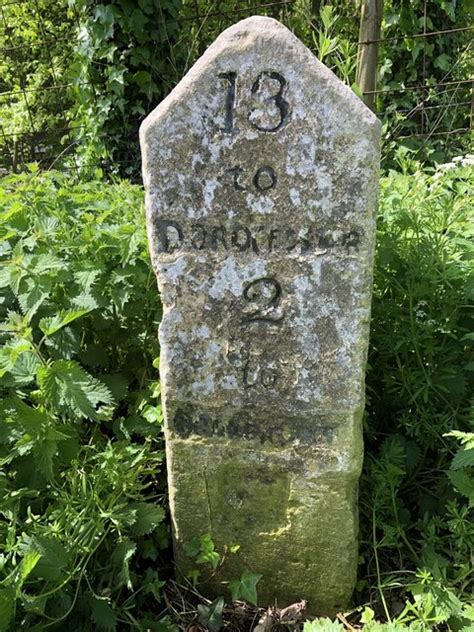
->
219 70 289 133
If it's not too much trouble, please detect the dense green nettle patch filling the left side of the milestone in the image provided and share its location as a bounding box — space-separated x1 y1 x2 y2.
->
0 173 167 631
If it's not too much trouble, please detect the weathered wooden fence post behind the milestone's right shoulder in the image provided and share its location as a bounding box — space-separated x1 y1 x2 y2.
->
356 0 383 109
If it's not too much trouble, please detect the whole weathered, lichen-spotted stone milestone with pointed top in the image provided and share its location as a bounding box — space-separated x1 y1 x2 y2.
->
141 17 379 613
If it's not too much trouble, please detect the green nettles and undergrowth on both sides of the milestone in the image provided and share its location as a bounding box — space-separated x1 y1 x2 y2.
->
0 162 474 632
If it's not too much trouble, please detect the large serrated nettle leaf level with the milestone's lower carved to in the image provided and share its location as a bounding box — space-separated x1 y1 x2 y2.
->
38 360 114 420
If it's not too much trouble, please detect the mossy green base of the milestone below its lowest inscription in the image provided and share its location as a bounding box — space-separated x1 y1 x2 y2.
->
167 424 362 616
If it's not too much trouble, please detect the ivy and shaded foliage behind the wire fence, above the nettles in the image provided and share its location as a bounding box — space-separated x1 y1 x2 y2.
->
0 0 472 179
